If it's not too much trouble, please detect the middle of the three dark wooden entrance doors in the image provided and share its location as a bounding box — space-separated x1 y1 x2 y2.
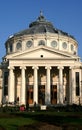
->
38 85 45 104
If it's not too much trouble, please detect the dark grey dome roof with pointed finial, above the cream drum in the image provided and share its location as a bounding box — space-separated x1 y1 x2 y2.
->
14 12 75 39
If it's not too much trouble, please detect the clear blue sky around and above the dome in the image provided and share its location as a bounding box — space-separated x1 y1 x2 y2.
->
0 0 82 62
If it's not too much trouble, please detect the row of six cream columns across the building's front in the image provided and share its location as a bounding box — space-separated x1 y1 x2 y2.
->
8 66 75 104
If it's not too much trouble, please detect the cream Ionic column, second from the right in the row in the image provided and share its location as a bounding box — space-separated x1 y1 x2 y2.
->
58 67 63 104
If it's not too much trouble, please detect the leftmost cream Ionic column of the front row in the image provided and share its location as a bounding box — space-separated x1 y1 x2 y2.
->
8 66 15 103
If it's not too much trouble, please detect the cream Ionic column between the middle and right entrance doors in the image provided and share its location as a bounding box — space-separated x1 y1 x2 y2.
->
45 66 51 104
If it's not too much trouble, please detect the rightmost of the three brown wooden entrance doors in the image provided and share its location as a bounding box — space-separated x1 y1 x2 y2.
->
51 85 57 104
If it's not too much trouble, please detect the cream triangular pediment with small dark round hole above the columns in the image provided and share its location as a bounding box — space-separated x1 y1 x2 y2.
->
8 46 78 59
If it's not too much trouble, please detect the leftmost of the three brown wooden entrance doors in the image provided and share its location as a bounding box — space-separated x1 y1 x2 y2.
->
27 85 33 104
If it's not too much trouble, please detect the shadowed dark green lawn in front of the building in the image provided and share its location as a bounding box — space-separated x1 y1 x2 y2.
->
0 111 82 130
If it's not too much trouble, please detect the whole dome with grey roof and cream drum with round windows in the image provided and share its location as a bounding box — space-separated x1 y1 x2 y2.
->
5 12 78 54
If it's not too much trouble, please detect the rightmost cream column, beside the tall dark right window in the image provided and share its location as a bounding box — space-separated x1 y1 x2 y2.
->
69 67 75 104
